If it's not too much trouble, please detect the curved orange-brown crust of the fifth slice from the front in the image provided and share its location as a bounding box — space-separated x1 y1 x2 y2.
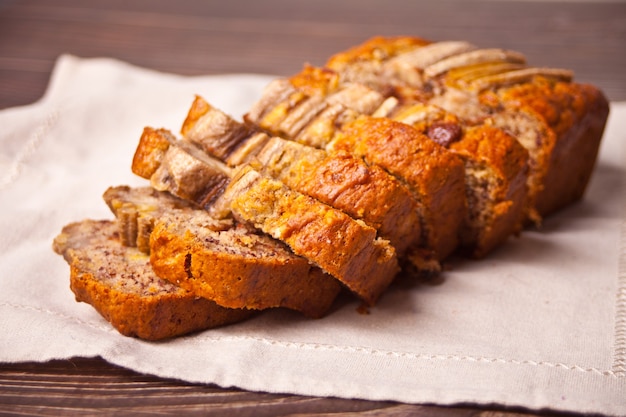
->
330 116 467 259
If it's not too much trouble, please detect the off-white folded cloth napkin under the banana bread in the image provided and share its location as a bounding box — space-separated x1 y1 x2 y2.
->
0 56 626 416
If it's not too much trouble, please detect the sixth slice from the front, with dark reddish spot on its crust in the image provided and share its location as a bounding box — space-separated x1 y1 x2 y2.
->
247 65 528 256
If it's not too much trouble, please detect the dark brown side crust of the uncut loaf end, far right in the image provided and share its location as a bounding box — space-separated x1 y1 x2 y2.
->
481 77 609 218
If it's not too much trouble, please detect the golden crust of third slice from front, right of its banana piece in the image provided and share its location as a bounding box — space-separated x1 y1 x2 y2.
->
217 166 399 305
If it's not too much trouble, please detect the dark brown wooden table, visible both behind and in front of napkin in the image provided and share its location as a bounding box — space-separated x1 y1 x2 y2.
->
0 0 626 417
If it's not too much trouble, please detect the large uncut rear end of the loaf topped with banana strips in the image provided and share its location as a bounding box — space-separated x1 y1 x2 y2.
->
327 37 609 223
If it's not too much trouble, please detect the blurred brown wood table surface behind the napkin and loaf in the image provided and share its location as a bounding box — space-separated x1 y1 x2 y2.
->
0 0 626 108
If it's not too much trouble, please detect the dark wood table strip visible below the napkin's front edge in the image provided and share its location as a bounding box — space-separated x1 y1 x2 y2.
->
0 358 564 417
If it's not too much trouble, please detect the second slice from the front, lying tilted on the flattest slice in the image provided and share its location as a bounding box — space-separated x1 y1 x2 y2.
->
104 186 341 318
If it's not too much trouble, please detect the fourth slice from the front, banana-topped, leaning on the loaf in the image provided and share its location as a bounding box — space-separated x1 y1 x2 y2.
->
182 97 426 264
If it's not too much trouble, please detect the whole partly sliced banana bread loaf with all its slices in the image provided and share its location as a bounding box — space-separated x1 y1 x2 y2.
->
54 37 608 339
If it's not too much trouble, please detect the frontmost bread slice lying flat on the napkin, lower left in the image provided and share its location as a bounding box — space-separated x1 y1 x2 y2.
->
53 220 253 340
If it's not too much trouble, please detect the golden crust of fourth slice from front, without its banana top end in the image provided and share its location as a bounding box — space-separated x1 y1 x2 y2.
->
258 138 421 257
